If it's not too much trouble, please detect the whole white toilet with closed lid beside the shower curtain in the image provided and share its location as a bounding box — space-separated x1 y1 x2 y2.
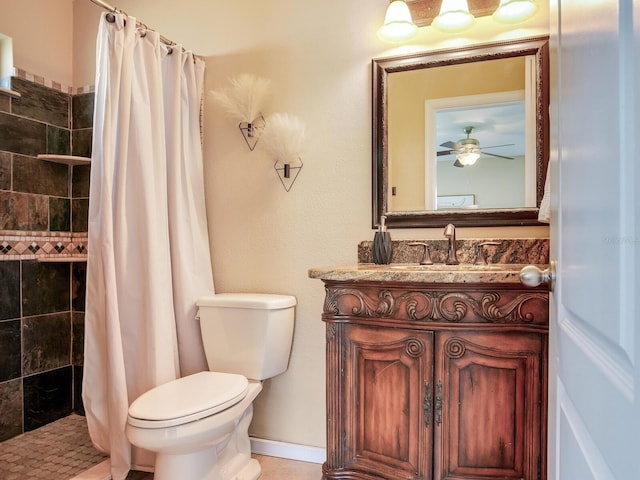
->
126 293 296 480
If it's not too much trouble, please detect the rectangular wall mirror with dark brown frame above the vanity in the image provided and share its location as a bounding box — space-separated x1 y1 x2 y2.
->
373 38 548 227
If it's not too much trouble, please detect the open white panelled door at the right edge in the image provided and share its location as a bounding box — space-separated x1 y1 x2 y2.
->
548 0 640 480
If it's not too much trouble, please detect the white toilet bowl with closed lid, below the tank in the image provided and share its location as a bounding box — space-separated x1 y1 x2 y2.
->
126 372 262 480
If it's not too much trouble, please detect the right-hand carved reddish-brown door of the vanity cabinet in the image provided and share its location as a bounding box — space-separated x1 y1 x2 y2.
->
434 331 546 480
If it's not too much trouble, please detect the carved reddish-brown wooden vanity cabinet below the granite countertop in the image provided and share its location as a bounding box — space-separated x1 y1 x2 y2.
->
323 281 548 480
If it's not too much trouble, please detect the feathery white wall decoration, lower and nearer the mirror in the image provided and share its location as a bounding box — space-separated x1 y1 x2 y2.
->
263 113 306 192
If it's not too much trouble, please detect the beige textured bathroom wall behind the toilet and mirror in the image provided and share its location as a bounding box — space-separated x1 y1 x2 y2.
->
0 0 548 447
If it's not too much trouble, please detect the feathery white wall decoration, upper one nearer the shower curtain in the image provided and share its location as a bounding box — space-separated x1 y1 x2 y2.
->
211 74 271 151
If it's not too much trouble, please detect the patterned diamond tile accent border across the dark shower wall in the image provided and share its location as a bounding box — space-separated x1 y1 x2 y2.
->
0 230 88 262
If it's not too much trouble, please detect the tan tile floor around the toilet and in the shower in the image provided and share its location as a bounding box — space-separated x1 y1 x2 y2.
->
0 415 322 480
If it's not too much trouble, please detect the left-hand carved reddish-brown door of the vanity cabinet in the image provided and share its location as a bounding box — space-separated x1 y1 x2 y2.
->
340 325 433 480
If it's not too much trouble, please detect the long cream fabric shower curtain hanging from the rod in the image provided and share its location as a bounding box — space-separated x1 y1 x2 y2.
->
82 13 213 480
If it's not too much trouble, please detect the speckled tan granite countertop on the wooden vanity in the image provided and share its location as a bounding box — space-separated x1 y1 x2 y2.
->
309 263 546 284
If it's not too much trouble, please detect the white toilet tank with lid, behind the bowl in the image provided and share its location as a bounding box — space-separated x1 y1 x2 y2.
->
197 293 296 380
